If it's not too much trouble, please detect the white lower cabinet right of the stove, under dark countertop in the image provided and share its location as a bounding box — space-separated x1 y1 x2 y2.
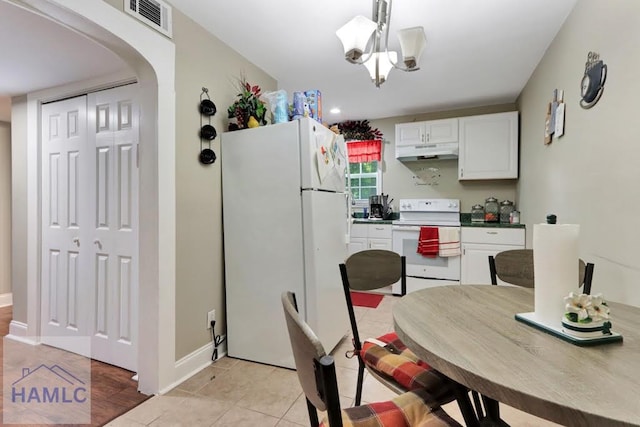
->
460 227 525 285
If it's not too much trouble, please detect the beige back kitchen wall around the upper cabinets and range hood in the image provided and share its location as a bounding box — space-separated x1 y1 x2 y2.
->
371 104 517 212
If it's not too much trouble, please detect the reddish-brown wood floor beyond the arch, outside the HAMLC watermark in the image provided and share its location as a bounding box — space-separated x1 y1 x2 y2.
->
0 307 150 426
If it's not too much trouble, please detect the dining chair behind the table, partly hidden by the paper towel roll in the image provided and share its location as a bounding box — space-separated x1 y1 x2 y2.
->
489 249 594 294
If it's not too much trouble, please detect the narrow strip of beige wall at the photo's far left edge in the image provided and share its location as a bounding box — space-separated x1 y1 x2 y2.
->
0 122 11 294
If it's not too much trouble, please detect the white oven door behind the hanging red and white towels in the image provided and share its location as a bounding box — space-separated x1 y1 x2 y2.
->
392 225 460 281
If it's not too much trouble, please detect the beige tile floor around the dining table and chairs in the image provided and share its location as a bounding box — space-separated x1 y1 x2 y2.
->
107 296 557 427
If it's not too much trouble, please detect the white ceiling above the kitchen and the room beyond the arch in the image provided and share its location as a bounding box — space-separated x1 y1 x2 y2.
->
0 0 576 122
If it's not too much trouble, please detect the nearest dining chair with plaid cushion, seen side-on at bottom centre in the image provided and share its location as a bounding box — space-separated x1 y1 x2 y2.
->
282 292 460 427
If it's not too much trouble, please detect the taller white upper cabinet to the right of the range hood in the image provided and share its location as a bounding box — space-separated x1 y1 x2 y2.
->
458 111 518 180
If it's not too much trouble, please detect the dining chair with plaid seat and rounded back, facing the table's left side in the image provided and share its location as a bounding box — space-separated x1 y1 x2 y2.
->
339 249 480 423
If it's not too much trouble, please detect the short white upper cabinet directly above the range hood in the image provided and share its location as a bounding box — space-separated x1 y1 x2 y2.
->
396 119 458 146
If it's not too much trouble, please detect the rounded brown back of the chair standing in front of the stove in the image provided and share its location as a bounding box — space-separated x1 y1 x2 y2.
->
340 249 406 291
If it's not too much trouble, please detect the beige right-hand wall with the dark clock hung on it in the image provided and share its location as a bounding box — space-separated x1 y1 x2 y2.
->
519 0 640 308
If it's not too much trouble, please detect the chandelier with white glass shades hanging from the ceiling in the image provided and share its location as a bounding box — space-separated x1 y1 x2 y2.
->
336 0 427 87
